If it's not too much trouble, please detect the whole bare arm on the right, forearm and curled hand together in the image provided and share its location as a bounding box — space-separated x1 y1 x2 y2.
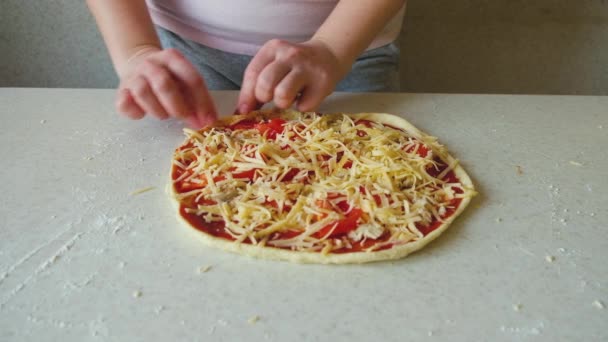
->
238 0 406 113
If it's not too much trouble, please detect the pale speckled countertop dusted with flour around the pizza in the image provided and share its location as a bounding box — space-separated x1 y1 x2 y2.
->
0 88 608 341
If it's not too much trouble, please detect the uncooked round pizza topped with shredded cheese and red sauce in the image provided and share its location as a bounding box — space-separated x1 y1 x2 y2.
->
170 110 475 263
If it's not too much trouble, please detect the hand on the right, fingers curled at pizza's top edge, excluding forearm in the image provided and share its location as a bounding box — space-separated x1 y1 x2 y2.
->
238 39 350 114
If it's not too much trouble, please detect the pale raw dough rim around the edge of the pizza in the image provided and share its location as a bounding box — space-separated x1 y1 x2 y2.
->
167 110 475 264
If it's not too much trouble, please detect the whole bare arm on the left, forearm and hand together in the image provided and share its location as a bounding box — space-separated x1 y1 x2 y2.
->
87 0 216 126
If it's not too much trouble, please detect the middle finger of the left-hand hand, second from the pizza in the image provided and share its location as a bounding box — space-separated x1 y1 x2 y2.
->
142 61 189 118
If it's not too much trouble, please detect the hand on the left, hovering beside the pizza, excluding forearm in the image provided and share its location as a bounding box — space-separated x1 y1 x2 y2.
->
116 47 217 128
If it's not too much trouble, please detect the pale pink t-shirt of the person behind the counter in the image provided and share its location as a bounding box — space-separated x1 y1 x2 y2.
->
147 0 405 55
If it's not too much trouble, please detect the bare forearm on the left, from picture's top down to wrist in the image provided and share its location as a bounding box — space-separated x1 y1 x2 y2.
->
87 0 160 76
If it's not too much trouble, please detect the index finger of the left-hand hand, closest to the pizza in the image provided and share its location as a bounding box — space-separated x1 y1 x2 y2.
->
154 49 217 122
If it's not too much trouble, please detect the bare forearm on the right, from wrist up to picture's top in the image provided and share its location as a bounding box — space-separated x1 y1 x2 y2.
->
312 0 406 74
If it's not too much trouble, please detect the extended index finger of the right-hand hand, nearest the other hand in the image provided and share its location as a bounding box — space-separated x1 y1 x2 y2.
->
238 40 279 114
